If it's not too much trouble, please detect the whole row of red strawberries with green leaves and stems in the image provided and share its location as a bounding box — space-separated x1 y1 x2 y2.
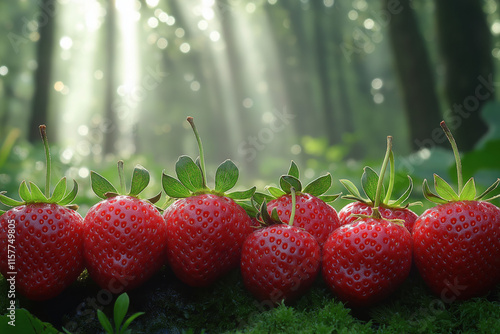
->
0 117 500 307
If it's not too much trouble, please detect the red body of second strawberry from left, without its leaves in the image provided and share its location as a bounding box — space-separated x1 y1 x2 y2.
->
84 196 167 293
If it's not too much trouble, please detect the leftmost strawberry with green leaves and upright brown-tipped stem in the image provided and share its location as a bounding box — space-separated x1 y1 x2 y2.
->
0 125 84 300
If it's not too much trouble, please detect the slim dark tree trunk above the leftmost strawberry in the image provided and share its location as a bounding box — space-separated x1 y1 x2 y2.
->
28 0 56 143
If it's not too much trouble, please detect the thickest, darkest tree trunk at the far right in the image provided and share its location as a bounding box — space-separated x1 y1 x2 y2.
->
436 0 495 150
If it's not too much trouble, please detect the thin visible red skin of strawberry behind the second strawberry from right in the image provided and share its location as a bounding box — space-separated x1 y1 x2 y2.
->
339 202 418 233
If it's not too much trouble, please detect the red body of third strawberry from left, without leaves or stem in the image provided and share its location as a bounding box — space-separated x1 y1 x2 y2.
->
163 194 252 287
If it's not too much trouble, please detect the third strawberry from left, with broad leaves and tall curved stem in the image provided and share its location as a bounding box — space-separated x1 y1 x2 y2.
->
162 117 255 287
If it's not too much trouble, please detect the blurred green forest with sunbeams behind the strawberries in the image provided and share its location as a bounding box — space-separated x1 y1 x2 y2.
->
0 0 500 213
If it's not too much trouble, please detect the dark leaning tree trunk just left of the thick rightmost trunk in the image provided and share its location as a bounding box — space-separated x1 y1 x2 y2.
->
383 0 440 150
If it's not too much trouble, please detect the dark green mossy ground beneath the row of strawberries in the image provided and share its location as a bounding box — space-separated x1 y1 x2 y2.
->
0 268 500 334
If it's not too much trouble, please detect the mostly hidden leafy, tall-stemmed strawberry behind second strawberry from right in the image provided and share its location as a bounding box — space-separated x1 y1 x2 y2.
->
339 138 422 233
